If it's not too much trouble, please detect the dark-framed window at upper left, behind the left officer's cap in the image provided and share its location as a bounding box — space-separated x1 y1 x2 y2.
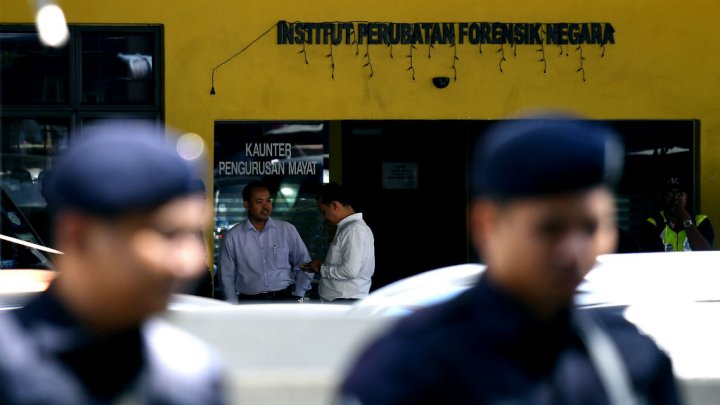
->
0 25 163 244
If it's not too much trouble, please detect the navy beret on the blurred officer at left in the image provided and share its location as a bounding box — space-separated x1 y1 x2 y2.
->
42 121 202 217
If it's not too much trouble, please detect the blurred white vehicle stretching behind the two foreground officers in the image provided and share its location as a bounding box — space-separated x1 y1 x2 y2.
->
162 252 720 404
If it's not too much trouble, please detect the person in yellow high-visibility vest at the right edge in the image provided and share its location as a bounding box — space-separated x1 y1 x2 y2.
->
643 176 715 252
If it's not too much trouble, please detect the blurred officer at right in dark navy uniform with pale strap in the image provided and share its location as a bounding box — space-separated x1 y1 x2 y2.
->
338 118 679 405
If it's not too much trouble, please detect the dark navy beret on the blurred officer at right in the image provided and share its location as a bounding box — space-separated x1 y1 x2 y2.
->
471 117 624 200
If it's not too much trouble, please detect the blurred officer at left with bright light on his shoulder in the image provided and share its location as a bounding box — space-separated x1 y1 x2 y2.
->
0 123 223 404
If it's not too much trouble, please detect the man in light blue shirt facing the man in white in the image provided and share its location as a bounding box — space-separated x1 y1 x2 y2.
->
220 181 312 303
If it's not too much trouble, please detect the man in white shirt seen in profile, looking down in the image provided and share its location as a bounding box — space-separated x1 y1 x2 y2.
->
303 183 375 302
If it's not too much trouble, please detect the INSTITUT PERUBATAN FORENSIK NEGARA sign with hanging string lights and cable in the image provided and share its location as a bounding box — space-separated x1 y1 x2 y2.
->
210 20 615 95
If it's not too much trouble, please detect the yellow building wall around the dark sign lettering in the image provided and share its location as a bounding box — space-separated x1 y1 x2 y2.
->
0 0 720 232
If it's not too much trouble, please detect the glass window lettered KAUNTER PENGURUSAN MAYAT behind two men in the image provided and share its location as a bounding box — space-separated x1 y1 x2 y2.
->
213 121 329 263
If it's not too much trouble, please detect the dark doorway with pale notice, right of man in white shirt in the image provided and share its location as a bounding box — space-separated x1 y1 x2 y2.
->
342 121 475 289
